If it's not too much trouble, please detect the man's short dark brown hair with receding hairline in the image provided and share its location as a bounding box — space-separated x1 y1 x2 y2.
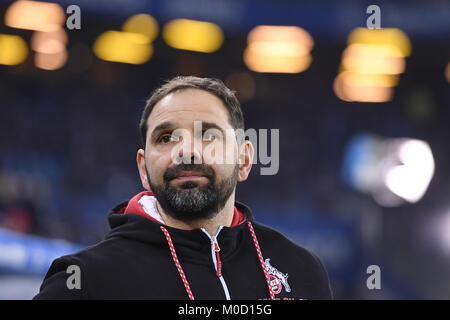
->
139 76 244 149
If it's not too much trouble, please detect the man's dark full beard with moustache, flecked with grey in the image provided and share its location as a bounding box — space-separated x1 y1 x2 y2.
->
147 164 239 222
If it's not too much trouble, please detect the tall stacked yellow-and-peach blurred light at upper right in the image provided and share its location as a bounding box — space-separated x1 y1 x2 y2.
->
333 28 411 102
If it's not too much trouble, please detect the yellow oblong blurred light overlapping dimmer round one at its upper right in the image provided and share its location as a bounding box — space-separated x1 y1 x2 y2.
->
94 31 153 64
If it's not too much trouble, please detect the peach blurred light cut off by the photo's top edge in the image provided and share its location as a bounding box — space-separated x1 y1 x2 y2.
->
5 0 66 31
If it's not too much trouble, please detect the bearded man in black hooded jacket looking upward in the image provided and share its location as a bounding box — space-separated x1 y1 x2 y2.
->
35 77 332 299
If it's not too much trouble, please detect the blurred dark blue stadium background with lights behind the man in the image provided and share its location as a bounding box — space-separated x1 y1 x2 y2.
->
0 0 450 299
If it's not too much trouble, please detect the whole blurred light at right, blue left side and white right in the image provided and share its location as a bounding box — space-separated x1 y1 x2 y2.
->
342 133 435 207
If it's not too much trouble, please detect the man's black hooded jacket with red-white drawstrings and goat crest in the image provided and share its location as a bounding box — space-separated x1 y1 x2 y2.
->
34 201 332 300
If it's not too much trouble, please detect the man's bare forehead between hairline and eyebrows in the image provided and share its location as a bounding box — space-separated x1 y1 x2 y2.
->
147 89 231 131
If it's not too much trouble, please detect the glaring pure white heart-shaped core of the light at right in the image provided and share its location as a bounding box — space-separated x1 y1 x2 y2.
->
384 140 434 203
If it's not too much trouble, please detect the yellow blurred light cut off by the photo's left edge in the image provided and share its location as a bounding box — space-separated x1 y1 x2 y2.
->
0 34 28 66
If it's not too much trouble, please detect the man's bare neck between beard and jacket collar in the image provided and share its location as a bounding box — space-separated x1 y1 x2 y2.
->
156 191 234 235
